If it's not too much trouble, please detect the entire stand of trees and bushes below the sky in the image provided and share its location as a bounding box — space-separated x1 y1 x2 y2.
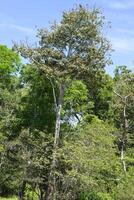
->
0 5 134 200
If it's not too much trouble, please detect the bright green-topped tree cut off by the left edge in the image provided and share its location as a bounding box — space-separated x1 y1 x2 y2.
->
0 45 21 195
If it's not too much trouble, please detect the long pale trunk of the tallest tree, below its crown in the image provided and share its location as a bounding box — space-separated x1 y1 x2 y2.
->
46 83 65 200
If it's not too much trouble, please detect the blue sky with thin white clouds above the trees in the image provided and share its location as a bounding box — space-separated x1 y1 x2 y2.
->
0 0 134 75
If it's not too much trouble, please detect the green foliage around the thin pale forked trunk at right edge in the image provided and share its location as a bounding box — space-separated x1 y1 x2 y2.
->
113 66 134 170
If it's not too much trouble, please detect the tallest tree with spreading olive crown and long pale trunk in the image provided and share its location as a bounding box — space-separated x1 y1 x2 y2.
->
14 6 110 199
